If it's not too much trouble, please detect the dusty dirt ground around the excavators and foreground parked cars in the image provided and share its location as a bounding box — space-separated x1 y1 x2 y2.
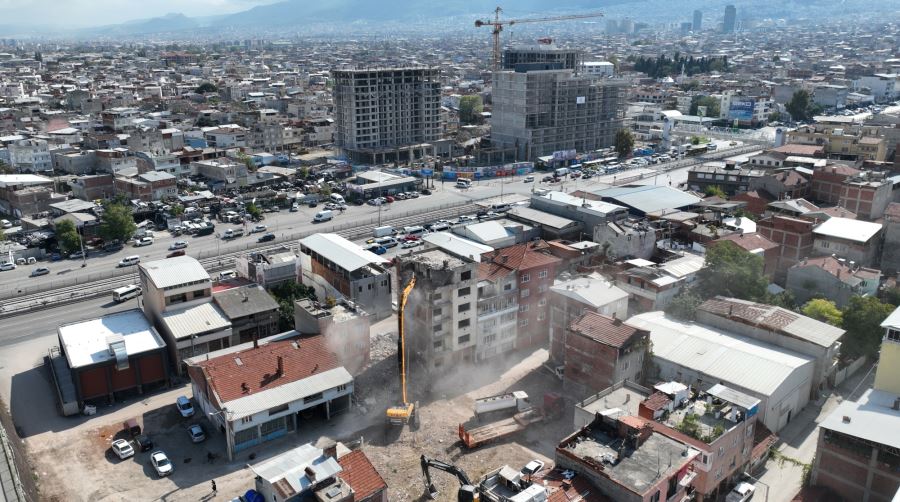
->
26 322 572 501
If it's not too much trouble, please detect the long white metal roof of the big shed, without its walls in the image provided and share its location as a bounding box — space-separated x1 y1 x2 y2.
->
626 312 814 396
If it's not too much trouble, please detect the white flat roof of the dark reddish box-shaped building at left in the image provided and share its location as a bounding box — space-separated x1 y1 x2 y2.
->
57 309 166 368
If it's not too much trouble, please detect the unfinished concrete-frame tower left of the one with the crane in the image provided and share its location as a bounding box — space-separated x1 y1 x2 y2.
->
332 67 443 164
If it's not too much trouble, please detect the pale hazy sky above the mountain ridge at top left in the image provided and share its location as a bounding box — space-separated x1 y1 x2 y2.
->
0 0 278 26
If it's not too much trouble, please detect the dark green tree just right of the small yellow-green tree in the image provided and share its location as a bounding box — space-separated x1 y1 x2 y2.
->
841 296 894 359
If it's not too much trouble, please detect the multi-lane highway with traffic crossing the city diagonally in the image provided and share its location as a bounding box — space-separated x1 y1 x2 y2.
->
0 146 749 316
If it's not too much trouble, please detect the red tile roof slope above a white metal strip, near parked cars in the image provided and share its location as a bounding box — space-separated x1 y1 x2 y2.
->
198 336 340 403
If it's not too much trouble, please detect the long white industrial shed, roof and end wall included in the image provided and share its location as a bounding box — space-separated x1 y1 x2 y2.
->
626 312 815 432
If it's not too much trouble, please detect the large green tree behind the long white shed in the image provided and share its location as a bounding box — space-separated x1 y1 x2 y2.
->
697 241 769 301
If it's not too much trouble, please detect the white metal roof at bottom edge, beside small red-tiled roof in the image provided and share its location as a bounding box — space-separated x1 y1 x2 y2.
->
250 443 343 493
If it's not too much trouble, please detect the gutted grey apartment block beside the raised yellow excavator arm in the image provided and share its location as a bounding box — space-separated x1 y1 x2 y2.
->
398 249 478 374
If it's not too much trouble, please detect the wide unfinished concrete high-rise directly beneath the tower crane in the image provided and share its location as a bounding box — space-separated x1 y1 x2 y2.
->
491 47 625 160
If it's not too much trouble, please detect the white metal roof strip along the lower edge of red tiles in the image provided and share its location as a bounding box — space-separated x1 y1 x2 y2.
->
223 366 353 421
